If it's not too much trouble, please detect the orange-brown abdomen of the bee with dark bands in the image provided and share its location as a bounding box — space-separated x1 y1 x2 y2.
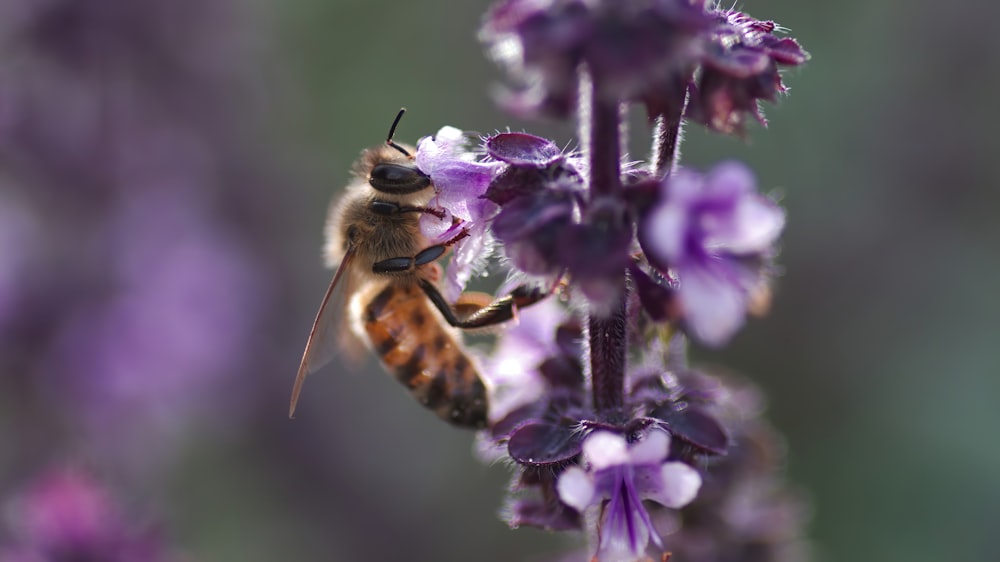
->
363 284 487 427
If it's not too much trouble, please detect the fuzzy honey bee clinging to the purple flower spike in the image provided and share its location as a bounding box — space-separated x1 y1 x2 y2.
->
288 110 545 428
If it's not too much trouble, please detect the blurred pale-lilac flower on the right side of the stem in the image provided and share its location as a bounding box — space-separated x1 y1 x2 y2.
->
640 163 785 345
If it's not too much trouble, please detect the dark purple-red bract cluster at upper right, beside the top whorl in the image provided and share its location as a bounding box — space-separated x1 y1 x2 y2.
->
688 10 809 133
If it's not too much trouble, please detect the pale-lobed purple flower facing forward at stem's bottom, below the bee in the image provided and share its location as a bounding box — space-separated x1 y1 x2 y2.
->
557 430 701 562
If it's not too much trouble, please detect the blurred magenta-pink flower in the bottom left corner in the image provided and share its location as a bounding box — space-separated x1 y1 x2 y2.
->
0 470 177 562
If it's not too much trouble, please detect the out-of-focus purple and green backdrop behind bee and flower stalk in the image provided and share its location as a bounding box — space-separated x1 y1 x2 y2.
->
0 0 1000 562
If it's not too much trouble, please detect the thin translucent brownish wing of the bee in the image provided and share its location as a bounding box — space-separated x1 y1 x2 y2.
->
288 246 355 418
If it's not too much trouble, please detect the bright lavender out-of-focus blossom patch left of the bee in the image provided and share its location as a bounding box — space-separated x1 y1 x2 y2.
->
50 191 264 450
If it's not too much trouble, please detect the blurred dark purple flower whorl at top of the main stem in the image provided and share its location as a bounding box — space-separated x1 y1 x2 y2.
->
480 0 712 116
